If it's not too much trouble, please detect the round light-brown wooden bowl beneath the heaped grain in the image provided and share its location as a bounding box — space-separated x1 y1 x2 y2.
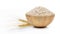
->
26 14 55 28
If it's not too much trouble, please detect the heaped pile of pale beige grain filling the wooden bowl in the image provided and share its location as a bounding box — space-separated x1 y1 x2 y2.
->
26 7 54 16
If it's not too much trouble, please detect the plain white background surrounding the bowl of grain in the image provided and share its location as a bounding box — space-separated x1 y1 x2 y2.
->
0 0 60 34
